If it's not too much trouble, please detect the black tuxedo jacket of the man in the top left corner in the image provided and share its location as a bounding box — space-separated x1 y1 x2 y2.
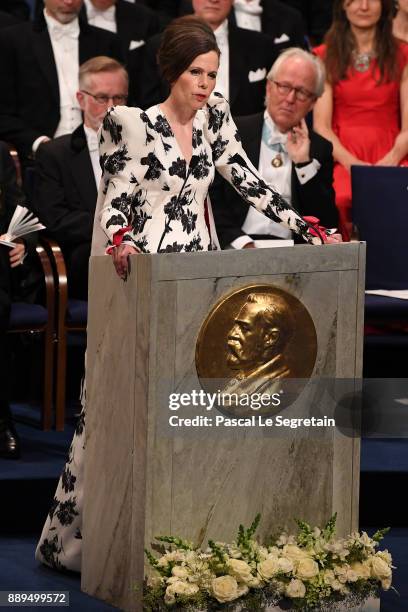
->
0 15 122 159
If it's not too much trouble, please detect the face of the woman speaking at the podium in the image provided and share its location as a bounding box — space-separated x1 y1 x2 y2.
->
171 51 219 111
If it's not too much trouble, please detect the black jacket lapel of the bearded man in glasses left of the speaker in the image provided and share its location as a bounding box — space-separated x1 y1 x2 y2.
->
71 125 97 212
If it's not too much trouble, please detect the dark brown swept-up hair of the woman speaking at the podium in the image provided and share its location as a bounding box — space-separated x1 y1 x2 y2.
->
157 15 220 85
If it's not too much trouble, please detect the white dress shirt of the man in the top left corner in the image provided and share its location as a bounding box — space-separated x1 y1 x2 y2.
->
44 9 82 138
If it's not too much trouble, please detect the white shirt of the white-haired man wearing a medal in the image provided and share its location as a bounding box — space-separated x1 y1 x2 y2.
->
231 111 321 249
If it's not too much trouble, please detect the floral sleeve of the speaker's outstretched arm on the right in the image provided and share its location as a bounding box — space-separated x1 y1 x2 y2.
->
206 94 321 244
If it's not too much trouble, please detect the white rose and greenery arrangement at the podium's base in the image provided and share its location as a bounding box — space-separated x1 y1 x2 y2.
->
143 515 393 612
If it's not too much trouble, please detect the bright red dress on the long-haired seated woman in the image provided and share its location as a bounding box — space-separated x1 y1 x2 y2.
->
314 43 408 240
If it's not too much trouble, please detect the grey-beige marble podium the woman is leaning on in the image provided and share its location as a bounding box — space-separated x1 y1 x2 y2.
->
82 243 365 610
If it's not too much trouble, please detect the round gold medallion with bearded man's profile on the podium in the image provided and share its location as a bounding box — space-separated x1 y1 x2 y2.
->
196 285 317 417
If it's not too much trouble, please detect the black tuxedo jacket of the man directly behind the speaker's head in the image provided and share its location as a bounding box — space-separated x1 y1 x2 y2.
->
137 21 276 115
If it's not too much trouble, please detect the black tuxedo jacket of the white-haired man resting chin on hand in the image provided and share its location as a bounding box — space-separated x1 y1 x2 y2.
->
210 113 338 248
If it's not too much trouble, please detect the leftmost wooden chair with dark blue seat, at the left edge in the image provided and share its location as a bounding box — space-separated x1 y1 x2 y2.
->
9 240 56 430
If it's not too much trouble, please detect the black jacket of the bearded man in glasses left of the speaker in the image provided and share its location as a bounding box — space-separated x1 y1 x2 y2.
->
33 125 97 251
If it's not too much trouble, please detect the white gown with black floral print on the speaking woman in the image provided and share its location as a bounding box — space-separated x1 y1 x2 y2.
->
36 94 319 571
